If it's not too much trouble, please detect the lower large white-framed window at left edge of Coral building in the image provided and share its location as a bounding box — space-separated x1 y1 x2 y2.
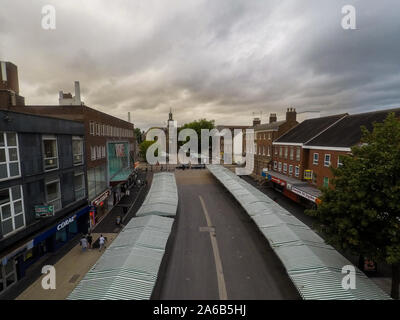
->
0 186 25 236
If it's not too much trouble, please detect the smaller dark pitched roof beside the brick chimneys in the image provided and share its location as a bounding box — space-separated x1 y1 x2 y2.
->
275 113 347 143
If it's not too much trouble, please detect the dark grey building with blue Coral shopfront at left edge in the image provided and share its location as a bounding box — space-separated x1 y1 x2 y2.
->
0 110 89 296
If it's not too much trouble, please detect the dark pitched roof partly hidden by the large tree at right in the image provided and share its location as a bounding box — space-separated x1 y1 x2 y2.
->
305 108 400 148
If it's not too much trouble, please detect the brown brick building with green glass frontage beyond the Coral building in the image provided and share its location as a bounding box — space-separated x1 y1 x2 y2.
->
0 69 136 227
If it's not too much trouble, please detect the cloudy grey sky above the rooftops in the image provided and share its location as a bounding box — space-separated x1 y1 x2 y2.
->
0 0 400 129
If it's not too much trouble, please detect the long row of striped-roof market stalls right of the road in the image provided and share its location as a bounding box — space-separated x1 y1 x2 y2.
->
207 165 390 300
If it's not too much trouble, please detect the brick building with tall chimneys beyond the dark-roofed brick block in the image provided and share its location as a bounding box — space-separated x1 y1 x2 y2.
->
253 108 298 177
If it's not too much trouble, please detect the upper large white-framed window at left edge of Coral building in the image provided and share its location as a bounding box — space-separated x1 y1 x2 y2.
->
0 132 20 180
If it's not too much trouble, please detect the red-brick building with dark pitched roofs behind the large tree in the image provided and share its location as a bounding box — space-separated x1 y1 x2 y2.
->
268 109 400 205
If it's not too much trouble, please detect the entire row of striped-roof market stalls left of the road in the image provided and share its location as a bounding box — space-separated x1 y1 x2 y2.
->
68 172 178 300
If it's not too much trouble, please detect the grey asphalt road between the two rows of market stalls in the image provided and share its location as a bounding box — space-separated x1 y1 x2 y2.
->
155 169 299 300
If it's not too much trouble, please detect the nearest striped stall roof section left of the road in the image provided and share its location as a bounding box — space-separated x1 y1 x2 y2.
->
67 215 174 300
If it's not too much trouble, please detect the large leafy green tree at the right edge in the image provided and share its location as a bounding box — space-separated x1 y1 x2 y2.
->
306 113 400 299
